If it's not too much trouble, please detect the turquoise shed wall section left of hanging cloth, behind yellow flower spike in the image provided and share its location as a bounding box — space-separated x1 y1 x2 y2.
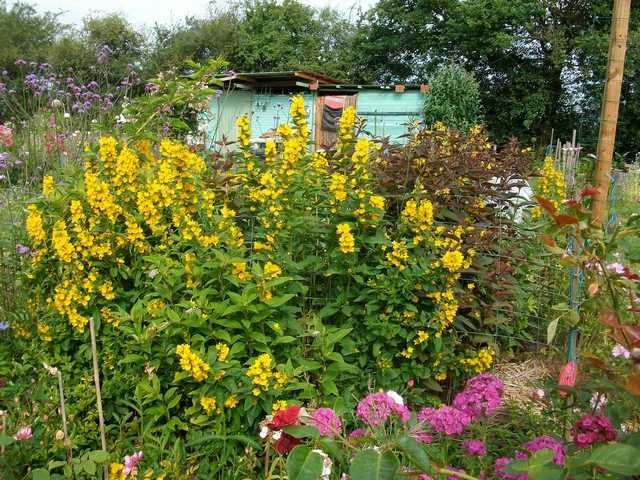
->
251 93 315 137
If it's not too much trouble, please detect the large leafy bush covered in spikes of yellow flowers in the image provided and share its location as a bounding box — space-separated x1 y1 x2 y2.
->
3 98 494 473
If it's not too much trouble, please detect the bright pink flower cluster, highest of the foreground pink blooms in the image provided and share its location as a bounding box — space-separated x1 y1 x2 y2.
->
452 373 504 420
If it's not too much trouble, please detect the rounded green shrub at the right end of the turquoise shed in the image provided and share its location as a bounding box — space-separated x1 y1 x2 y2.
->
424 64 482 130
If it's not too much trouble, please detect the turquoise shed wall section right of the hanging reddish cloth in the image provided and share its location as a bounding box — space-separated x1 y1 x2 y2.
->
357 90 424 143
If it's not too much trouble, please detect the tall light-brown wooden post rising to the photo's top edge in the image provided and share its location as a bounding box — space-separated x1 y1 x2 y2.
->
591 0 631 227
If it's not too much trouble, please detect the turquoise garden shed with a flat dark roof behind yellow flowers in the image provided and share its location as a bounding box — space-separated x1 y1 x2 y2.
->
201 70 428 149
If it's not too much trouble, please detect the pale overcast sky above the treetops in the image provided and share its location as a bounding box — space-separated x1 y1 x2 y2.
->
7 0 375 26
